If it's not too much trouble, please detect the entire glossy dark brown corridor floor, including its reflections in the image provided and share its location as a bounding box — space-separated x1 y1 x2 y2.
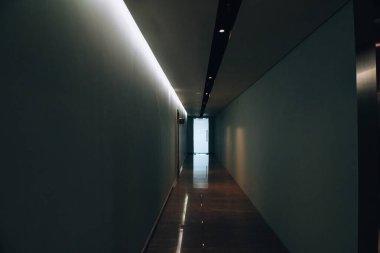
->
147 155 288 253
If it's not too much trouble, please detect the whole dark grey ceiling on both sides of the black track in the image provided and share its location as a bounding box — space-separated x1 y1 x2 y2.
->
125 0 348 116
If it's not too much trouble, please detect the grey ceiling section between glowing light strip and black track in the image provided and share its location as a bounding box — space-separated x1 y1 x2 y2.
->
121 0 218 115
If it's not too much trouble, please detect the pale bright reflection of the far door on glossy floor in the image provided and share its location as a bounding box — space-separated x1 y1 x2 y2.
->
193 154 209 189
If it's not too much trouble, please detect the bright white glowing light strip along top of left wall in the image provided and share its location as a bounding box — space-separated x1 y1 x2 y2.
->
102 0 187 115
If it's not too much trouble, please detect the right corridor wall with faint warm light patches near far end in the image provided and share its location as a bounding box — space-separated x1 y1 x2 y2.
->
216 3 358 253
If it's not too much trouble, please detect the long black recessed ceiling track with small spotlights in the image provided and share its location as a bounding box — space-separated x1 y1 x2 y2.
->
200 0 241 117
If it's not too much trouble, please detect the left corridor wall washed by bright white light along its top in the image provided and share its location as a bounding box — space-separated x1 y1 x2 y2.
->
0 0 186 253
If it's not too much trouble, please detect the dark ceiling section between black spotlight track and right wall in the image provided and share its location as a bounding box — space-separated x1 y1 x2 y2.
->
206 0 347 114
